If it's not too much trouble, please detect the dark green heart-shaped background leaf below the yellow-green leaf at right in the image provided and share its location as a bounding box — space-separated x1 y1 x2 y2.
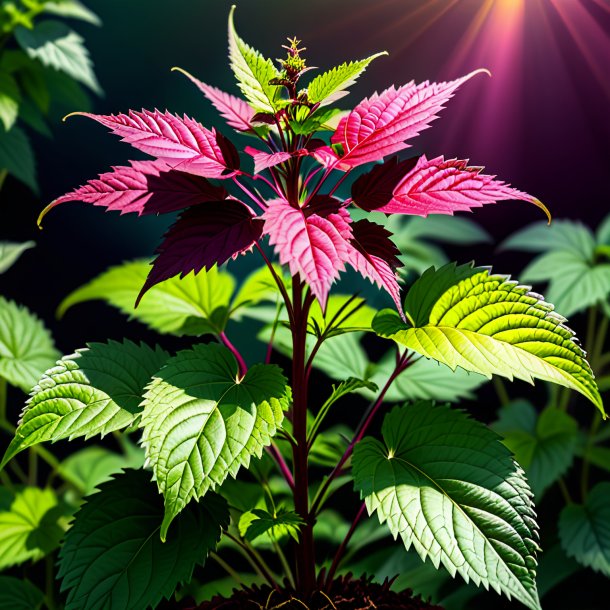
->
492 401 578 500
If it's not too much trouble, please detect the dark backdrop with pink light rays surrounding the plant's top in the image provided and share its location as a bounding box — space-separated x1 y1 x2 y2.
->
0 0 610 608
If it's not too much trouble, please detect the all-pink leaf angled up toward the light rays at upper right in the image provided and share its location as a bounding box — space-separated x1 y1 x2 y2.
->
326 70 484 170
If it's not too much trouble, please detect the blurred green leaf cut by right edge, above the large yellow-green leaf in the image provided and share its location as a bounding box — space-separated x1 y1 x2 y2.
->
522 249 610 316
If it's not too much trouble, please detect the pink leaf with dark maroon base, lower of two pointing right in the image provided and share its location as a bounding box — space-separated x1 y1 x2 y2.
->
355 156 548 216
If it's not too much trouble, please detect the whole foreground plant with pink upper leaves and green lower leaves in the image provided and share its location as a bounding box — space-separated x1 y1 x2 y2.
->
3 8 604 610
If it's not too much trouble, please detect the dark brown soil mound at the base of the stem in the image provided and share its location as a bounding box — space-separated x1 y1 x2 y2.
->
182 575 442 610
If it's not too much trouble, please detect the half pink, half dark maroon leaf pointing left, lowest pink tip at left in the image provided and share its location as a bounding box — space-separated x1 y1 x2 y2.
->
40 161 228 219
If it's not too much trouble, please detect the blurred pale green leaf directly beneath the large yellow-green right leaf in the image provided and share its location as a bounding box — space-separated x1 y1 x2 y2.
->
365 350 487 402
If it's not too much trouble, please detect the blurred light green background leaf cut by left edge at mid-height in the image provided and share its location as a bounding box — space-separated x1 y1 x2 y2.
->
0 296 59 392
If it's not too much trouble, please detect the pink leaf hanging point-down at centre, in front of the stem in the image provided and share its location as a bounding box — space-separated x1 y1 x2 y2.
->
263 196 351 308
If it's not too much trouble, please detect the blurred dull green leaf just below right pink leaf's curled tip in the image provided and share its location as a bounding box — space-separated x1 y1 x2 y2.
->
500 220 595 259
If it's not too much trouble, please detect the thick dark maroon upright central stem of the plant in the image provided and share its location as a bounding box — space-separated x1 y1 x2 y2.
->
292 277 316 594
